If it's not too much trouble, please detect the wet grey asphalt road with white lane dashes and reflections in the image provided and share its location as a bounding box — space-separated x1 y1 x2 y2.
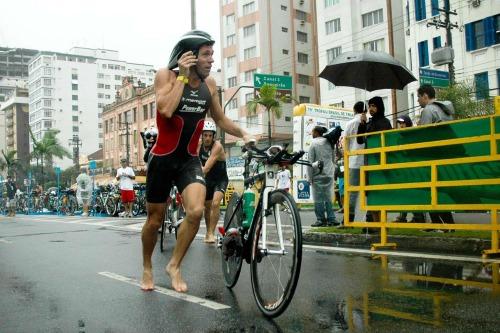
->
0 216 500 333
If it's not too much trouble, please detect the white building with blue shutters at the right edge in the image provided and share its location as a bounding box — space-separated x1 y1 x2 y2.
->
403 0 500 118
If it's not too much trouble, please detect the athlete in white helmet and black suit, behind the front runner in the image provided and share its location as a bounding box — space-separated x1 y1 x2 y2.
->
198 120 229 243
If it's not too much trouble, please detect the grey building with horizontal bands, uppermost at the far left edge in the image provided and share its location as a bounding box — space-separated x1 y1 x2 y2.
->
0 47 38 104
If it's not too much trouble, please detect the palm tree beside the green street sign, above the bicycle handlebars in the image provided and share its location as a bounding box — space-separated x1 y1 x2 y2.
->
246 83 293 146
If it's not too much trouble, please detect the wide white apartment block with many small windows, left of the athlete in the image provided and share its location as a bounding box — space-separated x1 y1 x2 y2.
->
29 48 154 168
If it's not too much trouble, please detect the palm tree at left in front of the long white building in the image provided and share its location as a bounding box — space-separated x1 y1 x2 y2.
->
28 126 71 187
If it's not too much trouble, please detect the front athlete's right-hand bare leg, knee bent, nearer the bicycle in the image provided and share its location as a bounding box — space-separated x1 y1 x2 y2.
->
165 183 206 292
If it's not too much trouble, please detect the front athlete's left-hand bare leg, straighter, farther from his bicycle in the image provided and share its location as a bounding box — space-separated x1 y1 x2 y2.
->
141 202 165 290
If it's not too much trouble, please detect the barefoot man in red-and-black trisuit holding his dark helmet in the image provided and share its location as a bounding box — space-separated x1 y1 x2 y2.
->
141 30 255 292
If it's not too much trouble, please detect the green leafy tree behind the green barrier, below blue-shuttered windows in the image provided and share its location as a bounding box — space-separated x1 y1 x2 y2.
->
437 81 494 119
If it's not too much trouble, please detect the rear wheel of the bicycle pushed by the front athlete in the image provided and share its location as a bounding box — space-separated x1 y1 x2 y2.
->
220 192 243 288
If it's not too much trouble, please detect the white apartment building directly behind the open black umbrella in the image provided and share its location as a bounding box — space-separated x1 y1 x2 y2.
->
316 0 408 120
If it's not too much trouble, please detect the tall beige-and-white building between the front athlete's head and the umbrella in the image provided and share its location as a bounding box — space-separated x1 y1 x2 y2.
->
220 0 319 155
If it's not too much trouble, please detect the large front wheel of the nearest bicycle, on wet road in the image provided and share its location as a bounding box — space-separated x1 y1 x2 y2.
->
250 190 302 317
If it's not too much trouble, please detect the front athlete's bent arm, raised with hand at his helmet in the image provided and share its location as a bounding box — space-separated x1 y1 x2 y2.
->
155 51 197 118
